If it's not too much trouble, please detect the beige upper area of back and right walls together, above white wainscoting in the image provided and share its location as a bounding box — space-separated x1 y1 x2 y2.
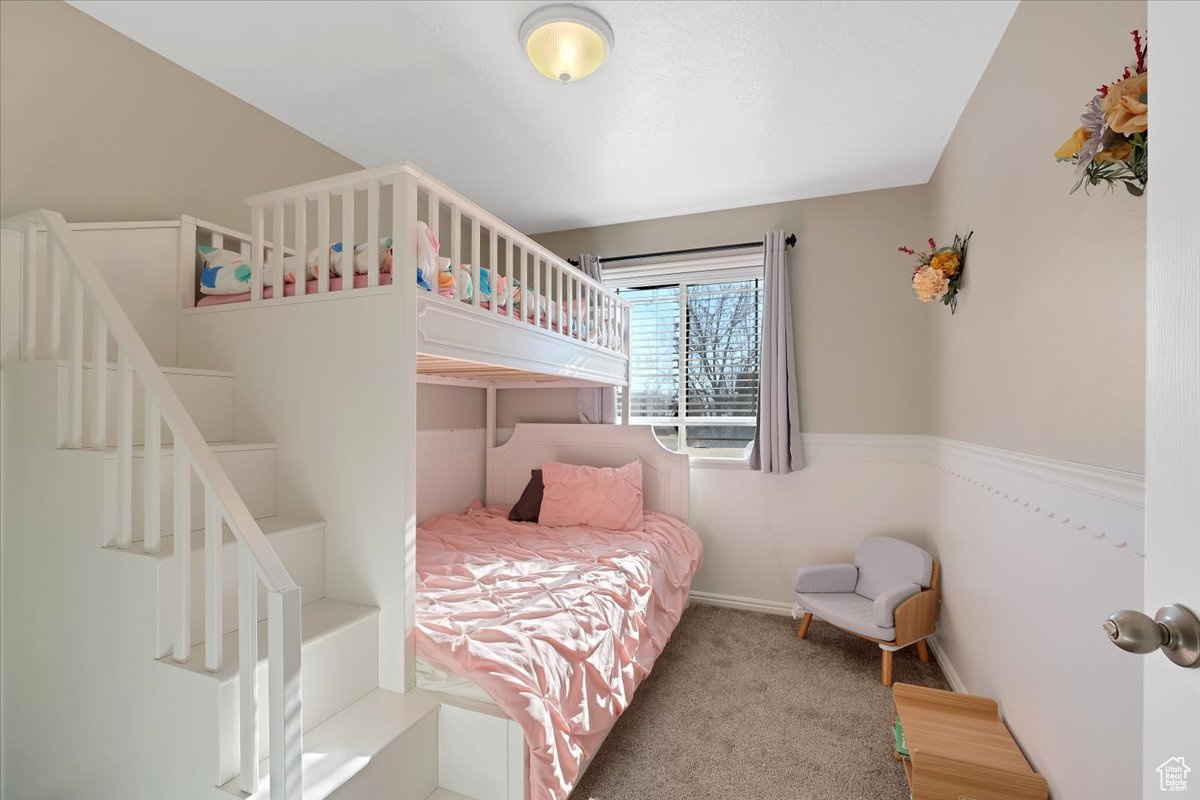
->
530 1 1146 471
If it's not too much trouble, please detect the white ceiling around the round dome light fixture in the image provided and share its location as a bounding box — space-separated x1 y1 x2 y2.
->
72 0 1016 233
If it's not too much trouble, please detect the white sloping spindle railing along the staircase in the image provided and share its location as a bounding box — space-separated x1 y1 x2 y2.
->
0 209 302 800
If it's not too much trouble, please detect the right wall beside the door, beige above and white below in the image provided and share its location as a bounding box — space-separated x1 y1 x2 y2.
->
928 2 1154 799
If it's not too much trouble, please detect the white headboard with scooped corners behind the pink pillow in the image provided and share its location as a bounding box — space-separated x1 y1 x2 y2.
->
487 422 690 522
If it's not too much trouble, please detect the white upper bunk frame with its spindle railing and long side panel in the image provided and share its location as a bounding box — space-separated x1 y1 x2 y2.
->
180 162 630 402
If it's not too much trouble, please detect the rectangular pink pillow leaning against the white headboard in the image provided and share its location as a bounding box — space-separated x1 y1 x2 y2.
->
538 461 642 530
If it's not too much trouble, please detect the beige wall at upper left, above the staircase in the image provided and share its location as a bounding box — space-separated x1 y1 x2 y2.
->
0 0 359 230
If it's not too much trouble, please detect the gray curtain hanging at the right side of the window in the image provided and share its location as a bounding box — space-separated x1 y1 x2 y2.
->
750 230 804 475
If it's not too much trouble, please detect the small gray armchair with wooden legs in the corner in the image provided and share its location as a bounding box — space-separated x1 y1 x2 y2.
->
796 536 941 686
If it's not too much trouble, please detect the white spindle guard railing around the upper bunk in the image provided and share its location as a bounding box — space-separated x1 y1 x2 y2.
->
246 162 630 355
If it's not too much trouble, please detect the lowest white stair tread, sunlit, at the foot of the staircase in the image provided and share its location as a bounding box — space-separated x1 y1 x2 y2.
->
221 688 441 800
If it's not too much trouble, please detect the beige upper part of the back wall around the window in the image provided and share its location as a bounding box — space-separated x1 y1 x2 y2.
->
530 186 929 433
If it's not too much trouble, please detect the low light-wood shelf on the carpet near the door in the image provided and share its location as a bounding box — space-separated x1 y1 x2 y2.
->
892 684 1048 800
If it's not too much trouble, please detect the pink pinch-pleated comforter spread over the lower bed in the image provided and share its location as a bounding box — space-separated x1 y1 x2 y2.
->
416 505 703 800
